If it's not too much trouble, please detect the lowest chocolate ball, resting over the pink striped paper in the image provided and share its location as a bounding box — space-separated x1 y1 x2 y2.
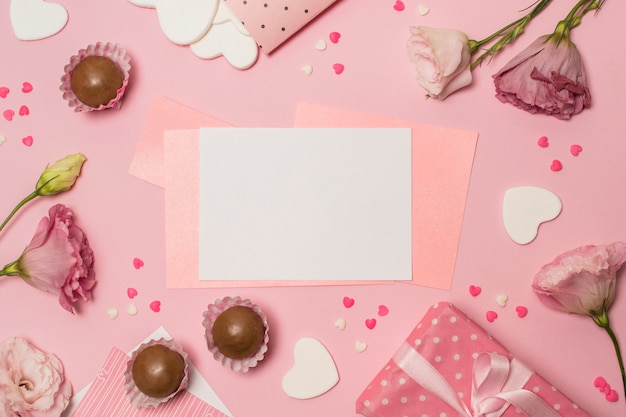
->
132 345 185 398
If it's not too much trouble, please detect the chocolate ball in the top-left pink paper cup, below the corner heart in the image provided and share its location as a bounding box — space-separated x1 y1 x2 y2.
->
70 55 124 108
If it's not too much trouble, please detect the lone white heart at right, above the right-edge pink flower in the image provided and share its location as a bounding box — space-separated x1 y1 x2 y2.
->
502 186 563 245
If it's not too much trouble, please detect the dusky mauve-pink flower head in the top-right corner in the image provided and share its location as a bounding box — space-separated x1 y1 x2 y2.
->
493 35 591 119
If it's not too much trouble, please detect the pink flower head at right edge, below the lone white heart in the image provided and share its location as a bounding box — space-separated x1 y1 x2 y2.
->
532 242 626 317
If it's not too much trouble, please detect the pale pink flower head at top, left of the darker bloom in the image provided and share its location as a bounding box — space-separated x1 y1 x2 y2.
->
407 26 472 100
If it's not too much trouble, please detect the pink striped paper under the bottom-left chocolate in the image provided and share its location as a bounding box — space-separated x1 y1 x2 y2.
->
70 348 228 417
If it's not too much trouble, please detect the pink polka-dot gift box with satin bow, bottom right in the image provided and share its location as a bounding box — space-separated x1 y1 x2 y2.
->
356 302 590 417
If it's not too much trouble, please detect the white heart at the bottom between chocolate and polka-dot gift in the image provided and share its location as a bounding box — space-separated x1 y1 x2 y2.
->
283 337 339 400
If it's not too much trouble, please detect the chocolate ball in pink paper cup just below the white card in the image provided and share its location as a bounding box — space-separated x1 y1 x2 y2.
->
212 306 265 359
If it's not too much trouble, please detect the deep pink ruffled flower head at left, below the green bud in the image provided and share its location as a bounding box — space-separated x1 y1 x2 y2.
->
0 204 96 313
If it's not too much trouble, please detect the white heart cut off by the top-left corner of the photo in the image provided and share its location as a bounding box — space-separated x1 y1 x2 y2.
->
9 0 68 41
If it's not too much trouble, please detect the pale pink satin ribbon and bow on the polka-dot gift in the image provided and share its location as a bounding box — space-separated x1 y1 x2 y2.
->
393 342 561 417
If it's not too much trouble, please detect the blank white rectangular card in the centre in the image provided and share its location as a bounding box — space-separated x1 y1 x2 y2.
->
198 128 412 281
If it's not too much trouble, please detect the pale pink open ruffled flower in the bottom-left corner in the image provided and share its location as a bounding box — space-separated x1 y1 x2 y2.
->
0 338 72 417
